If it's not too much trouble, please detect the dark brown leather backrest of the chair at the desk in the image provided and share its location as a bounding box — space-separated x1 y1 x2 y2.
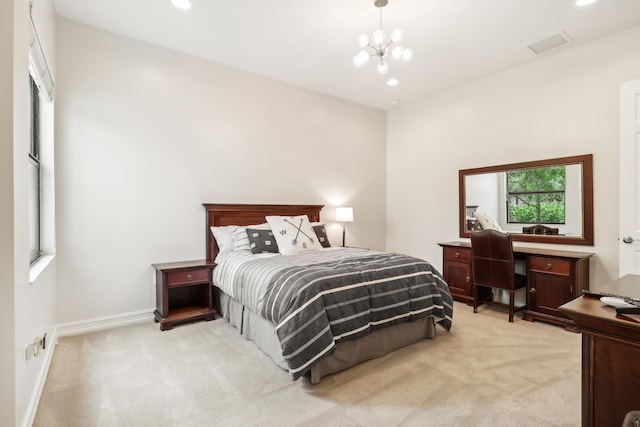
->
471 230 515 290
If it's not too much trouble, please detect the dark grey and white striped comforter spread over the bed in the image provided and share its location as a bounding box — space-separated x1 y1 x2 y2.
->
213 249 453 379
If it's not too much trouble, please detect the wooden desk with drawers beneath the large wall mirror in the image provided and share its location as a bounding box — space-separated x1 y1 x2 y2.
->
438 242 593 328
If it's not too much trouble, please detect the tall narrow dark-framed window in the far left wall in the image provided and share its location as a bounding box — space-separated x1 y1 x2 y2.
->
28 76 41 264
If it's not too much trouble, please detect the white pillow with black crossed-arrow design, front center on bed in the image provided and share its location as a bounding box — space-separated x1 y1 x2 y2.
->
267 215 322 255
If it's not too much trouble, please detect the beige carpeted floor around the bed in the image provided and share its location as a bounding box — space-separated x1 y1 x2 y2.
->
34 303 581 427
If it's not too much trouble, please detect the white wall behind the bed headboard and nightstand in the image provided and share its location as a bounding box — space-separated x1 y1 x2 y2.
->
56 20 386 325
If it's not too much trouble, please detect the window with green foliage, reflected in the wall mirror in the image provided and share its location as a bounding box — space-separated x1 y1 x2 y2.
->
507 166 566 224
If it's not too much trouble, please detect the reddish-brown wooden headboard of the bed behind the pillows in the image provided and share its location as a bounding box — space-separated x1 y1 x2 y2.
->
202 203 324 262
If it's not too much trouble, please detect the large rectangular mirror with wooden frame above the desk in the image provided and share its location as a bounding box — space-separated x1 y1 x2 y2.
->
458 154 593 245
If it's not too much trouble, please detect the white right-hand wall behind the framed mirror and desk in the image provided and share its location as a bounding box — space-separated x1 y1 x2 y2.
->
387 27 640 288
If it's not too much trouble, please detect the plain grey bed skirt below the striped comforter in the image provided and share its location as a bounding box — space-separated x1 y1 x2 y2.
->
215 289 436 384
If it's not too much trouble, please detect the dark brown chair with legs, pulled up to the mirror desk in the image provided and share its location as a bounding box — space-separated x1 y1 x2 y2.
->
471 230 527 322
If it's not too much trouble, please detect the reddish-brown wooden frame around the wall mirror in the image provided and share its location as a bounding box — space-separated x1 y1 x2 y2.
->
458 154 593 245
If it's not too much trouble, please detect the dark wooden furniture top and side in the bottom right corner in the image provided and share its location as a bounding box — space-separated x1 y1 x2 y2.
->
560 275 640 427
